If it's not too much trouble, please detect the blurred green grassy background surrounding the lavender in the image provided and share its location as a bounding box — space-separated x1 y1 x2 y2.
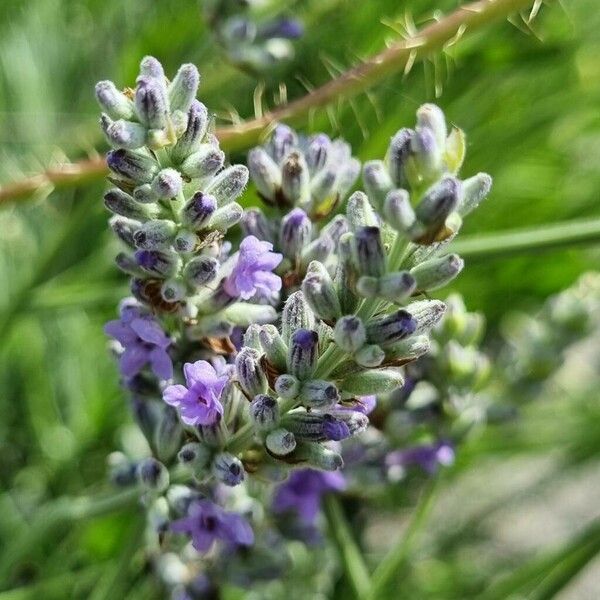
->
0 0 600 600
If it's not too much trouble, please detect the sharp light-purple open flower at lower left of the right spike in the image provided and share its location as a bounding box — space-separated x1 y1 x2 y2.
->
163 360 230 425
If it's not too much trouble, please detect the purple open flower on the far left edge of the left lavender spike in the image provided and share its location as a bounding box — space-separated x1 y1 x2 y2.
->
104 301 173 379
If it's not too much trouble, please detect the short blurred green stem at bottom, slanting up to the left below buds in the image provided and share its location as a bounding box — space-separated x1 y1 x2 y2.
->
324 494 371 600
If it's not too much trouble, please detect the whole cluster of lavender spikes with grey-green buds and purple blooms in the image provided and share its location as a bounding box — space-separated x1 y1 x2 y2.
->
96 57 490 597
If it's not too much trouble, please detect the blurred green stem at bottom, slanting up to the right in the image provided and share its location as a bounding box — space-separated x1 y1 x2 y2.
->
368 476 440 600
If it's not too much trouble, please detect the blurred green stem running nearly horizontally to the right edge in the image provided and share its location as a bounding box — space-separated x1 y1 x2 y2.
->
450 219 600 259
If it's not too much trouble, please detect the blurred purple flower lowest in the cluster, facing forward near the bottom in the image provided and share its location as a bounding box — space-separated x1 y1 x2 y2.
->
171 500 254 552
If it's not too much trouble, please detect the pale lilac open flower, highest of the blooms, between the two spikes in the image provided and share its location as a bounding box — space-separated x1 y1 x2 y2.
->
224 235 283 300
